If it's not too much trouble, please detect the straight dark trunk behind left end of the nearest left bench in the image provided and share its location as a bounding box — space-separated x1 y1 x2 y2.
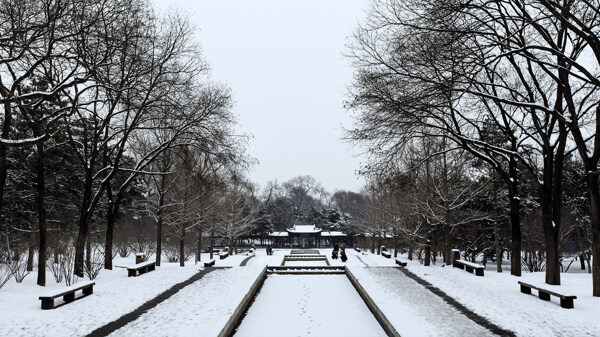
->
36 142 47 286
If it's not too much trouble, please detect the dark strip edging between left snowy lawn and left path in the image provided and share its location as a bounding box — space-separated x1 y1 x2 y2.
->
87 267 231 337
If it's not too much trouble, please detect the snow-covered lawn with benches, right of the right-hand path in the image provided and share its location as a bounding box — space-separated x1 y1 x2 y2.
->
408 261 600 337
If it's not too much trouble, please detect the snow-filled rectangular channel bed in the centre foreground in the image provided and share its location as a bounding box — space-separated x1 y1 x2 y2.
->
234 275 387 337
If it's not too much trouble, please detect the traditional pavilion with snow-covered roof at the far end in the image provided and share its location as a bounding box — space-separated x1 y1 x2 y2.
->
269 225 350 248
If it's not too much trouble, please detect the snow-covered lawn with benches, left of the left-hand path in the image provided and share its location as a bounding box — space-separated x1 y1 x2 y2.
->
0 260 200 336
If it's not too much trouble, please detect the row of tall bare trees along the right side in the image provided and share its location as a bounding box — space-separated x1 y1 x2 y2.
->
348 0 600 296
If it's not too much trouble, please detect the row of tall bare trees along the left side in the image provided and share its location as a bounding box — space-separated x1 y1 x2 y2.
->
0 0 246 285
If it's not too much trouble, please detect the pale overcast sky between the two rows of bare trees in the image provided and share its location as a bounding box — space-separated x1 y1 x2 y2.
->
155 0 368 192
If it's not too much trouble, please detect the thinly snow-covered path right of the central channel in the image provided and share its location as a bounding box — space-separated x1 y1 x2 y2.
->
351 267 492 336
